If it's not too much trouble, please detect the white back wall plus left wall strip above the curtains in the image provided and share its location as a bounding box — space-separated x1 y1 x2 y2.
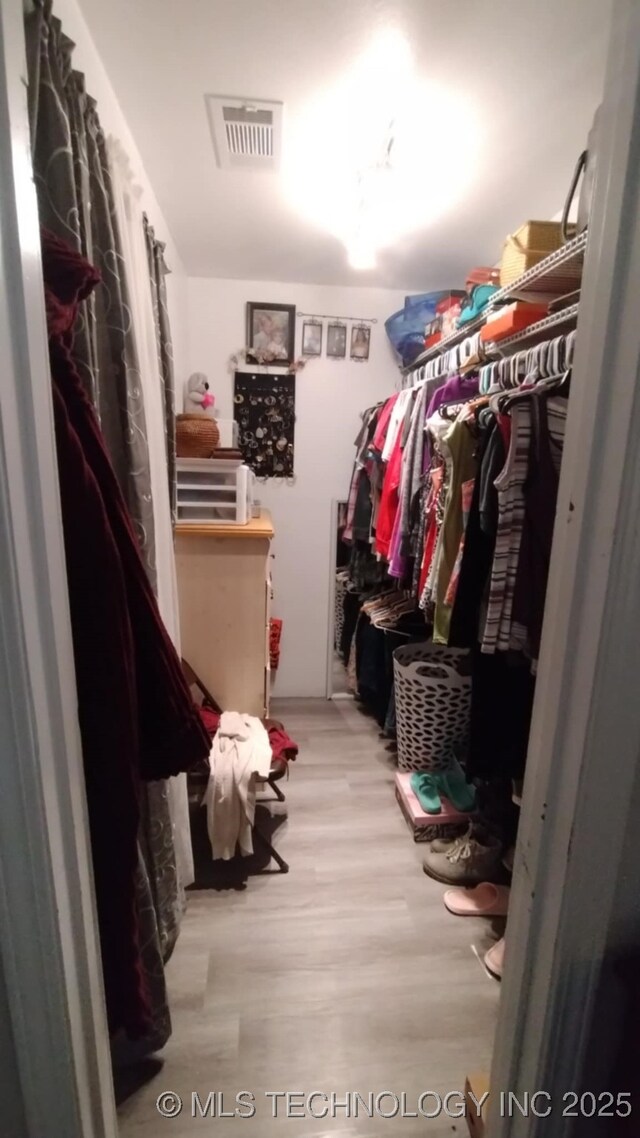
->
42 0 404 695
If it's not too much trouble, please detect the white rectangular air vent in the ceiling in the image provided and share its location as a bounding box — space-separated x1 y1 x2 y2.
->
205 94 282 170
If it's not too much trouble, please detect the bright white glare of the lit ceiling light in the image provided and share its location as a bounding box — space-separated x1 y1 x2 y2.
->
282 31 479 271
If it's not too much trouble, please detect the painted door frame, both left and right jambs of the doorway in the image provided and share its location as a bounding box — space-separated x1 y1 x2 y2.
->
0 0 640 1138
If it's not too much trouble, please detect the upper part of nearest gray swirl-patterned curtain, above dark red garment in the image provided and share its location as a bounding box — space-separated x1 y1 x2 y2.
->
27 0 155 583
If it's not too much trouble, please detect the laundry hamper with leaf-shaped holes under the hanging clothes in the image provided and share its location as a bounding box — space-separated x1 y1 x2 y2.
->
393 641 471 770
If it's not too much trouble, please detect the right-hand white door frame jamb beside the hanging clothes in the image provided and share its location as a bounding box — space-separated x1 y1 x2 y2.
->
489 0 640 1138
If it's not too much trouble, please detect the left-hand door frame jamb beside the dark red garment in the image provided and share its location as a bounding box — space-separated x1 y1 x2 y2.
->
0 0 117 1138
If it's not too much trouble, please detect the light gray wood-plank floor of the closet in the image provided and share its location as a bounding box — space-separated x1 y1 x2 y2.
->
120 700 500 1138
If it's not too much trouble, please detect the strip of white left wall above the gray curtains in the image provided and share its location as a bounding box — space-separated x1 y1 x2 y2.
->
55 0 188 390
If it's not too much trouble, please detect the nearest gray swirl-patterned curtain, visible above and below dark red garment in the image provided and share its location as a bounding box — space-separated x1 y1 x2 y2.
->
25 0 183 1058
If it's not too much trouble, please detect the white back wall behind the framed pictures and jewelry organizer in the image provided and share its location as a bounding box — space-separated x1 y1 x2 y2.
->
188 278 404 696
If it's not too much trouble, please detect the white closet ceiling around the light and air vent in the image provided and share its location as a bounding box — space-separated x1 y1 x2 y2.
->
80 0 610 290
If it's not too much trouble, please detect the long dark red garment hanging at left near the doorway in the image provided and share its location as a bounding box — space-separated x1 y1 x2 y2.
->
42 232 210 1038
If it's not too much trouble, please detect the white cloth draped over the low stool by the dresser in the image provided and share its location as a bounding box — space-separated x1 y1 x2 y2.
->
204 711 271 861
